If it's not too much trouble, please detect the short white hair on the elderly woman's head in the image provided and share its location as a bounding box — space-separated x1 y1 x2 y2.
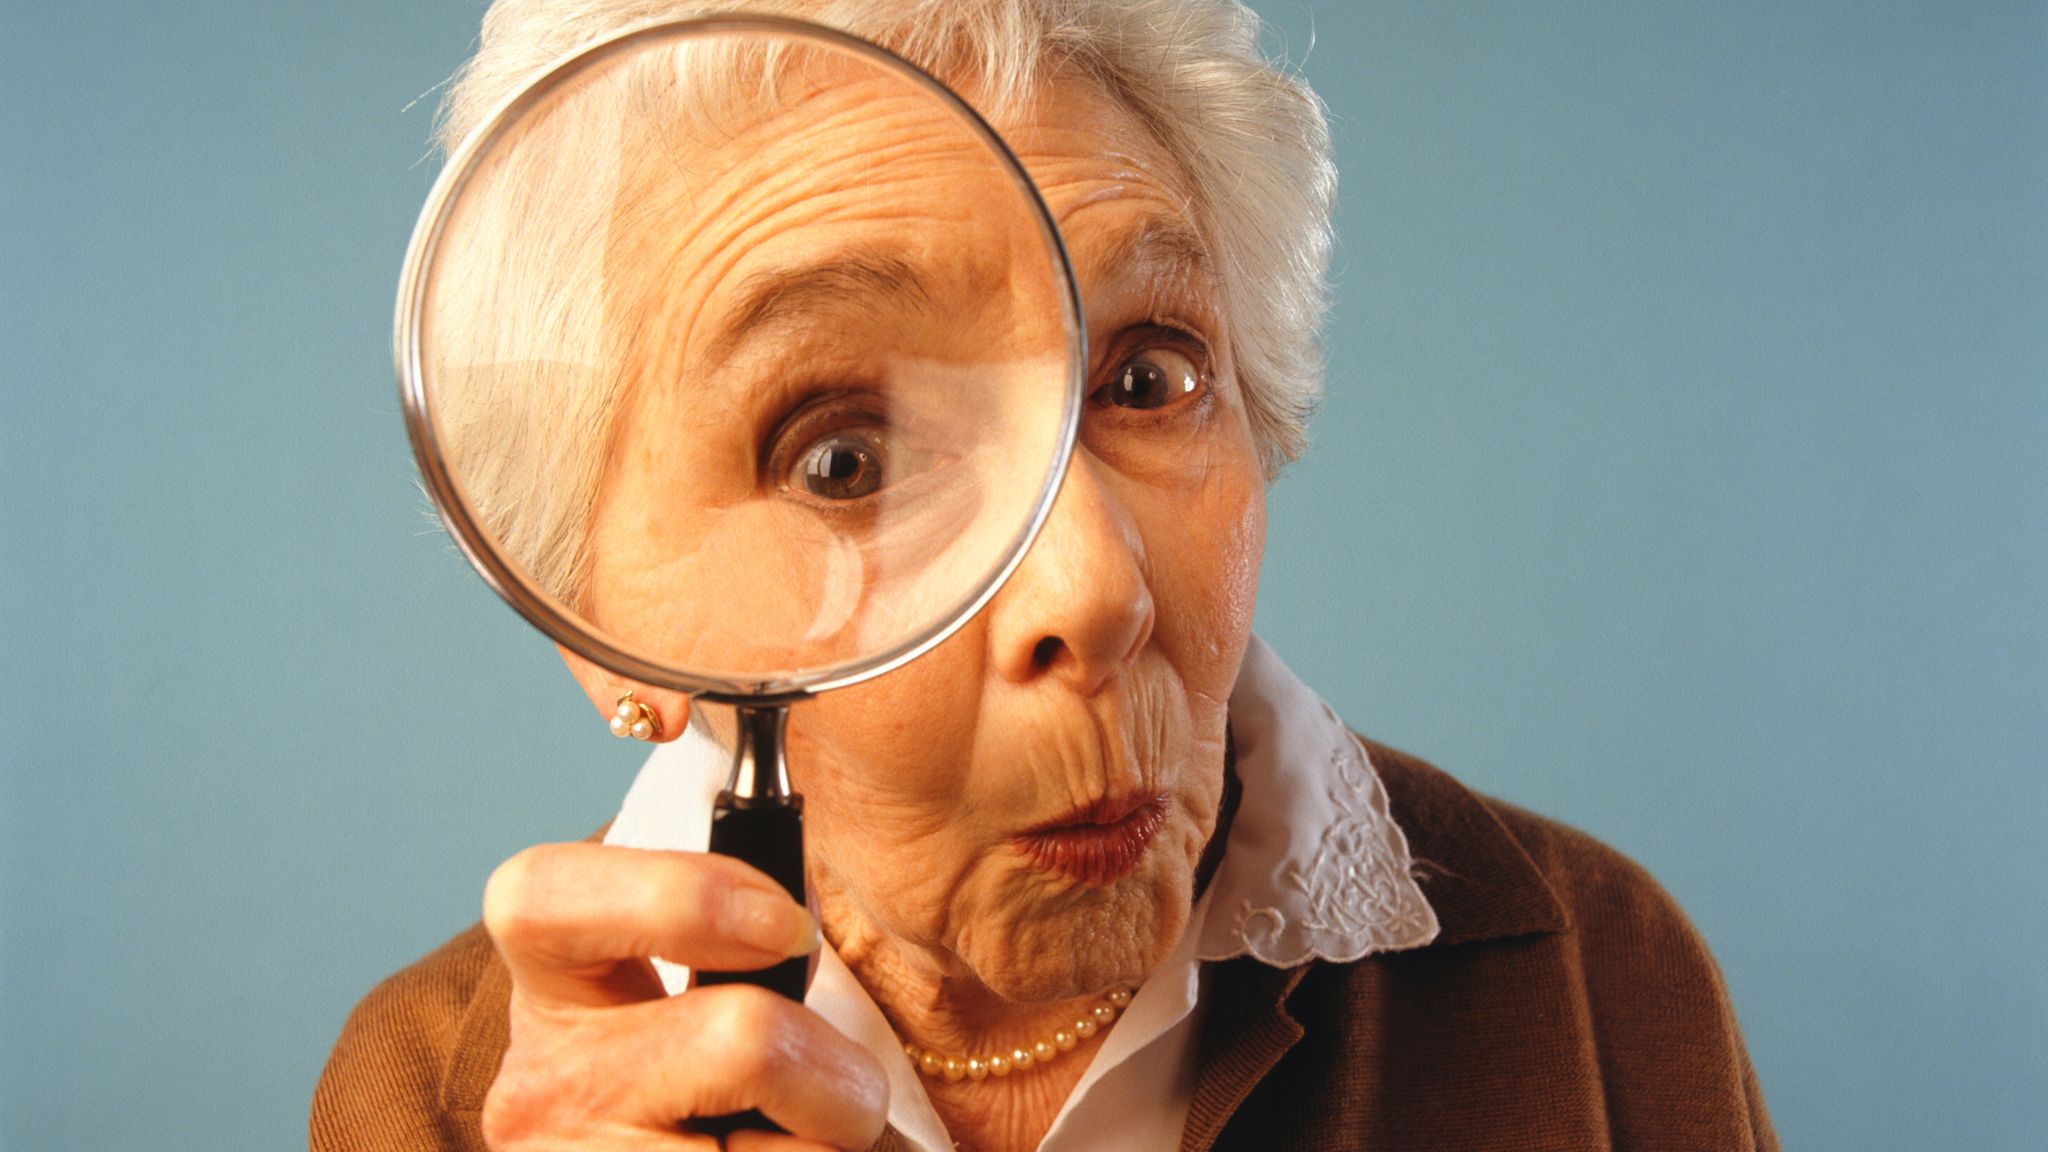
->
438 0 1337 601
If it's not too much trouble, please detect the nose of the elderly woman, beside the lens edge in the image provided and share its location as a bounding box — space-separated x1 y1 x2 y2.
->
989 449 1155 695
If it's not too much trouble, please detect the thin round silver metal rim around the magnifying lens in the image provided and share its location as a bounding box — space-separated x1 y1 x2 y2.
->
393 14 1087 705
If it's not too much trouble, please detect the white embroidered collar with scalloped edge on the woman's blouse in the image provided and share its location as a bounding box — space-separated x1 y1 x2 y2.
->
604 635 1438 967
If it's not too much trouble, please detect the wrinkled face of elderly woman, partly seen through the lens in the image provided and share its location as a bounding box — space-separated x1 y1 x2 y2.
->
584 67 1264 1000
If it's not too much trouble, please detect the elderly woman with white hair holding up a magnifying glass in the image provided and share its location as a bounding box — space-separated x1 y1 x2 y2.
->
311 0 1776 1152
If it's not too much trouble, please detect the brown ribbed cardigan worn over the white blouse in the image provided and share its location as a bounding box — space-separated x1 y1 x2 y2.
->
311 744 1778 1152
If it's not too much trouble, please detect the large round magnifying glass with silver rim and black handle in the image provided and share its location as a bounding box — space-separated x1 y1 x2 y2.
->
397 4 1085 1049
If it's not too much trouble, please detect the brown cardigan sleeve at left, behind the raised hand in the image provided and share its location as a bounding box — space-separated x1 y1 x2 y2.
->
309 927 506 1152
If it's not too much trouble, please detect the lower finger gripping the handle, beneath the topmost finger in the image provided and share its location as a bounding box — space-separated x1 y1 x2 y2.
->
622 984 889 1148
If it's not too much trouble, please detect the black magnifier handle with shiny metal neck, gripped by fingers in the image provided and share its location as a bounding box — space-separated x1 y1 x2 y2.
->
690 705 811 1138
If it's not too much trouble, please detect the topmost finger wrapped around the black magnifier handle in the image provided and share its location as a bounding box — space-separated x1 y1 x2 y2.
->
483 832 819 1004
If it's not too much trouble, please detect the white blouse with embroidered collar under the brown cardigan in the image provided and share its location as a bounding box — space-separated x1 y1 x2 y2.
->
604 637 1438 1152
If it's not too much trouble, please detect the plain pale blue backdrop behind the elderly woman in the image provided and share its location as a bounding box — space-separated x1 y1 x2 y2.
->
0 0 2048 1150
